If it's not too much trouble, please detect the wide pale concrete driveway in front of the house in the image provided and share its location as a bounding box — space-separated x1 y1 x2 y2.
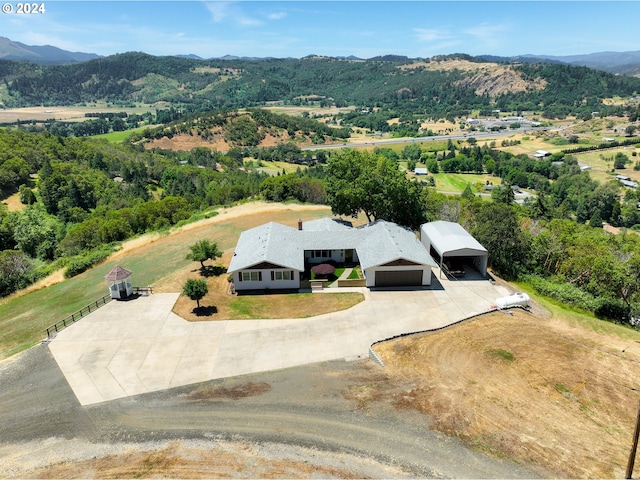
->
49 275 509 405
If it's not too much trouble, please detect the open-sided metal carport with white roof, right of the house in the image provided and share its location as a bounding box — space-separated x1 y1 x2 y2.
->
420 220 489 277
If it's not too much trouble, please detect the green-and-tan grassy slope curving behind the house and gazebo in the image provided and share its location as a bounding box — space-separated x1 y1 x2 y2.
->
0 204 340 360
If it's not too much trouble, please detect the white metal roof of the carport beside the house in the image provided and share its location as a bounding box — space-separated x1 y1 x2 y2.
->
420 220 488 256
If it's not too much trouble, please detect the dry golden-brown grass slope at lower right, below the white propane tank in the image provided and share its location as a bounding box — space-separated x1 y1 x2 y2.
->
375 310 640 478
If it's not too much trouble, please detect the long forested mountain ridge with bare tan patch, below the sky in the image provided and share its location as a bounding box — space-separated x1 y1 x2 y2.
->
0 53 640 118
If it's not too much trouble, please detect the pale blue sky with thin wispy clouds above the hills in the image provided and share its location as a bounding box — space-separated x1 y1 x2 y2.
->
0 0 640 58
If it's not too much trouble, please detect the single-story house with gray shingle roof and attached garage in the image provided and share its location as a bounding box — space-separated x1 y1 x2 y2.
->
227 218 437 291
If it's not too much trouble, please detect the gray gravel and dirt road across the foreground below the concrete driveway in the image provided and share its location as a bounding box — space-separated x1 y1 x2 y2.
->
0 345 534 478
